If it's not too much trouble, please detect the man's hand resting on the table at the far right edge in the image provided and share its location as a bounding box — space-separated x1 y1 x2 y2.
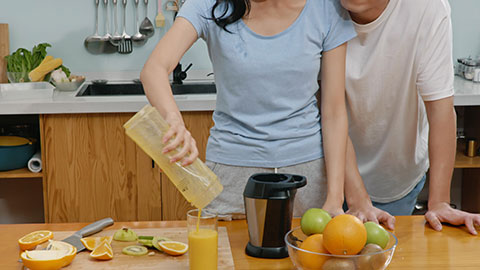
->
425 202 480 235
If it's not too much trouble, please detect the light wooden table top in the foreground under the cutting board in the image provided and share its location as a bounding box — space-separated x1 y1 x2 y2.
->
0 216 480 270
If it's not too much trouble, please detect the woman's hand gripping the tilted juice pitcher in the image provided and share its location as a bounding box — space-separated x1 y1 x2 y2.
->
162 114 198 166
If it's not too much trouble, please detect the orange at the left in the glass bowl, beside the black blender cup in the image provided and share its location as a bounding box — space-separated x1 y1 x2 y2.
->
298 234 328 270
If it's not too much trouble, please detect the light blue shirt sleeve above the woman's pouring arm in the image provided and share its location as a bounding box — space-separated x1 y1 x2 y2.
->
177 0 215 39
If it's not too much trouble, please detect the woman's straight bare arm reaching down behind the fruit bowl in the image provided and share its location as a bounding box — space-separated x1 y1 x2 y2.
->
321 43 348 215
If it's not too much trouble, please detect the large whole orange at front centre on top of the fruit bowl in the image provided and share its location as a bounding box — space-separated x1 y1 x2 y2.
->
323 214 367 255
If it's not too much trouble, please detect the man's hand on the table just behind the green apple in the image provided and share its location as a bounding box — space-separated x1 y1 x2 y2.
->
347 203 395 230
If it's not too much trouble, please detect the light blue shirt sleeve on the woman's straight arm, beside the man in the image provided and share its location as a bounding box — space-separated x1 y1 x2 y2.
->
323 0 357 51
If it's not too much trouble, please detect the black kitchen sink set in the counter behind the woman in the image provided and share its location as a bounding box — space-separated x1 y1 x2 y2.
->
76 83 217 97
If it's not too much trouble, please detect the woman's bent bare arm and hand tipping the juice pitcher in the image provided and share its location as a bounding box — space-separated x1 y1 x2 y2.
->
140 17 198 166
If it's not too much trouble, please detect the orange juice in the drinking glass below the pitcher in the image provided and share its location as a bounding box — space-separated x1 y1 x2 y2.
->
188 229 218 270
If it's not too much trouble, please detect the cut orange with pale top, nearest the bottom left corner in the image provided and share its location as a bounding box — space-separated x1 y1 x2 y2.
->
20 247 77 270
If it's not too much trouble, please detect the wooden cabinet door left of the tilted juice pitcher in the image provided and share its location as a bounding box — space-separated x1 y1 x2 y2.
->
42 113 162 222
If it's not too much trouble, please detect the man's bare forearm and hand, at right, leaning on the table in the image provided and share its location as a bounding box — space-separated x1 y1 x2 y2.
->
425 97 480 235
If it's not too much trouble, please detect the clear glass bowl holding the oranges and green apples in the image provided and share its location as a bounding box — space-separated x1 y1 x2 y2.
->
285 227 398 270
